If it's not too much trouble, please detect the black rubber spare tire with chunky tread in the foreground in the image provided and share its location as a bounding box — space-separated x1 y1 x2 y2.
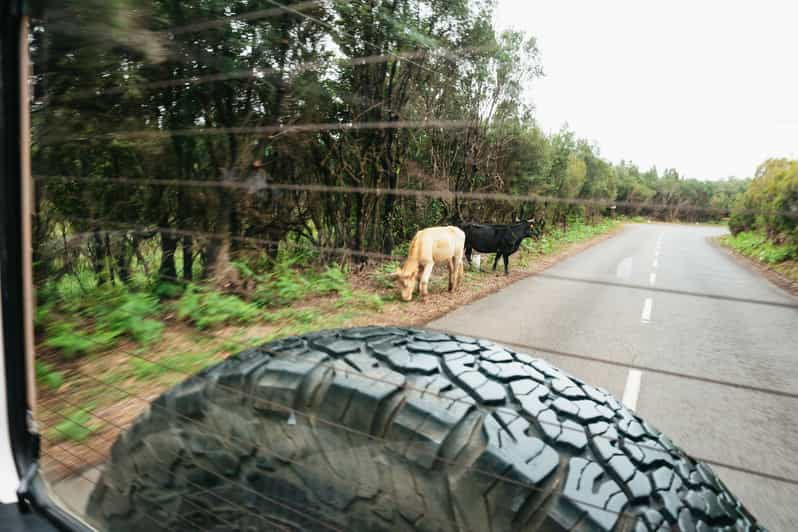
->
88 327 761 532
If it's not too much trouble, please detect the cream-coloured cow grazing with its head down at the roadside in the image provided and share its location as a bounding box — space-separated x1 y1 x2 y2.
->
393 226 465 301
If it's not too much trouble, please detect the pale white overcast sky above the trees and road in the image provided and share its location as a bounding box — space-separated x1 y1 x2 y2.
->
496 0 798 179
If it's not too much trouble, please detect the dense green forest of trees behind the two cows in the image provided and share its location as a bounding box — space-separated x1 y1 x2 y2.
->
31 0 747 283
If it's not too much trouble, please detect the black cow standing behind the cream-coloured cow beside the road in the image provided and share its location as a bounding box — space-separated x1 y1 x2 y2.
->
460 219 545 275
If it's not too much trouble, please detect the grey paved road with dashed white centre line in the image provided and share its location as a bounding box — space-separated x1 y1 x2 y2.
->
429 224 798 531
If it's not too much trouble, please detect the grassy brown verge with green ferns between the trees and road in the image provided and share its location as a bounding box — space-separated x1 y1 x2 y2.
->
36 214 621 478
